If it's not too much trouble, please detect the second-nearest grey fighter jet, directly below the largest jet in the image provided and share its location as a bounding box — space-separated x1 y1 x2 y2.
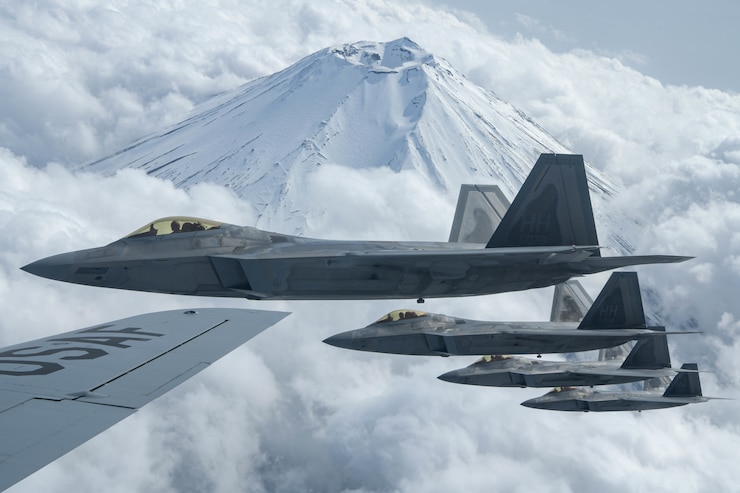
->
324 272 687 356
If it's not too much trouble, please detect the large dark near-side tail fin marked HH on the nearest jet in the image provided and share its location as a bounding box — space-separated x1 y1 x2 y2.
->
486 154 600 256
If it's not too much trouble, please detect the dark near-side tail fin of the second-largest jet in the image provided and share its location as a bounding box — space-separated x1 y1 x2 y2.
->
578 272 646 330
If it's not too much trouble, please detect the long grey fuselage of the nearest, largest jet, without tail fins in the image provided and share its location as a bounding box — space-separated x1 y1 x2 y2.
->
24 218 685 299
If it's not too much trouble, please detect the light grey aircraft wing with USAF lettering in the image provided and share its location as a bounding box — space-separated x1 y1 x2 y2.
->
0 308 288 490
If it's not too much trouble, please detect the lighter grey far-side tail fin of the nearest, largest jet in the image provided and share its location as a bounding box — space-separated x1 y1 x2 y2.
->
449 185 509 243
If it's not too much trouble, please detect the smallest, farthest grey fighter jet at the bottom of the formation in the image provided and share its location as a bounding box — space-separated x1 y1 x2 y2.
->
522 363 714 412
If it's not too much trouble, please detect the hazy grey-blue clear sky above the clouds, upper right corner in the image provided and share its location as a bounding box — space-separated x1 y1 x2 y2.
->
427 0 740 93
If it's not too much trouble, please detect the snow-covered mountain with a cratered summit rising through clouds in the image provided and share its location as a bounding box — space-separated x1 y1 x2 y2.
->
81 38 632 253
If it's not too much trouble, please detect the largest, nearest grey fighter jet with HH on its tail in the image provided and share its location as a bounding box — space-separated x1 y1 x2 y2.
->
23 154 690 302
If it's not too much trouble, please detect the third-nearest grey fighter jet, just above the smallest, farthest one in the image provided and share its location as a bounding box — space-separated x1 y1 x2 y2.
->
438 327 678 387
